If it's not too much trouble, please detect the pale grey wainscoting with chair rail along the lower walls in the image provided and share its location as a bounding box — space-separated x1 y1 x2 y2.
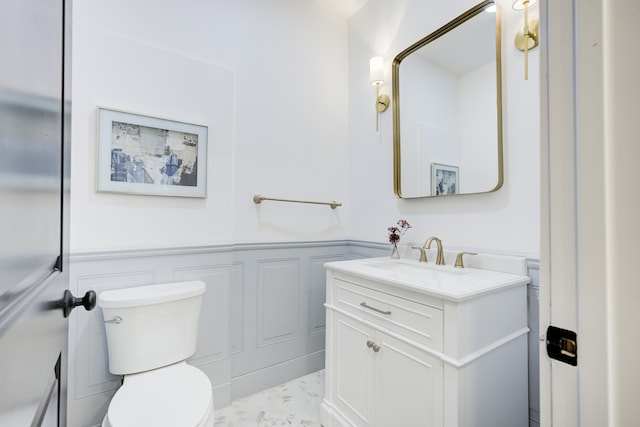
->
68 241 539 427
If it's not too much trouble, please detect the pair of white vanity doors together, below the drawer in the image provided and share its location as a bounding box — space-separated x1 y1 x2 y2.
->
331 313 443 427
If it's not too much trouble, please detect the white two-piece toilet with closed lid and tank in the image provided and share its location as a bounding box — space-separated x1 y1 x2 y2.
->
98 281 215 427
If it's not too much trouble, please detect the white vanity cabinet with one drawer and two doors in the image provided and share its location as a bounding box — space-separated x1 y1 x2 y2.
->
321 260 528 427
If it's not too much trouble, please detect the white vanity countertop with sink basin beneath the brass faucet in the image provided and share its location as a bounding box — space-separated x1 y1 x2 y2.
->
325 257 529 301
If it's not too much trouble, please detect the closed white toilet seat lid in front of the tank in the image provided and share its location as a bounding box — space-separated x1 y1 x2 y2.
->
107 363 213 427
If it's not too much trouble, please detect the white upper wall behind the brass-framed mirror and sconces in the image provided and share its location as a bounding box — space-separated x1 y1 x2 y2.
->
349 0 540 257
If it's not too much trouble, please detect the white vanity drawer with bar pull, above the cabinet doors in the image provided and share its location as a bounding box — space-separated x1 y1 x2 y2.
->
334 279 444 351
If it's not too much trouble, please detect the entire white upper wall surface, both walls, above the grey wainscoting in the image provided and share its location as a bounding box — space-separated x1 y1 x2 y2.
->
71 0 539 256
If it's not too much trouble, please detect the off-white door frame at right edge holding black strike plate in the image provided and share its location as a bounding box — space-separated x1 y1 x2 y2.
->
540 0 640 427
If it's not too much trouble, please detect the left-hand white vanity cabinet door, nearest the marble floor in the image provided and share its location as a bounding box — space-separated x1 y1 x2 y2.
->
331 313 376 426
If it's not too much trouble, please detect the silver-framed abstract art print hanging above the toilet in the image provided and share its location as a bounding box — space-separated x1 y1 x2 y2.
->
97 107 208 197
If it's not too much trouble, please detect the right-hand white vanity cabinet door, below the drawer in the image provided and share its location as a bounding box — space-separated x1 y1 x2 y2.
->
375 332 444 427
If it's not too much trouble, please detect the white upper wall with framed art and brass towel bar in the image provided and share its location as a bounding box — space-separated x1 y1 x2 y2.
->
71 0 349 252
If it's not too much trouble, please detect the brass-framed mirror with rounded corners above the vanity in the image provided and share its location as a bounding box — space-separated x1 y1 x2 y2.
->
392 0 503 198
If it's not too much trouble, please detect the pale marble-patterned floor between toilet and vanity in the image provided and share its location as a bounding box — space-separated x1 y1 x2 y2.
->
215 369 324 427
